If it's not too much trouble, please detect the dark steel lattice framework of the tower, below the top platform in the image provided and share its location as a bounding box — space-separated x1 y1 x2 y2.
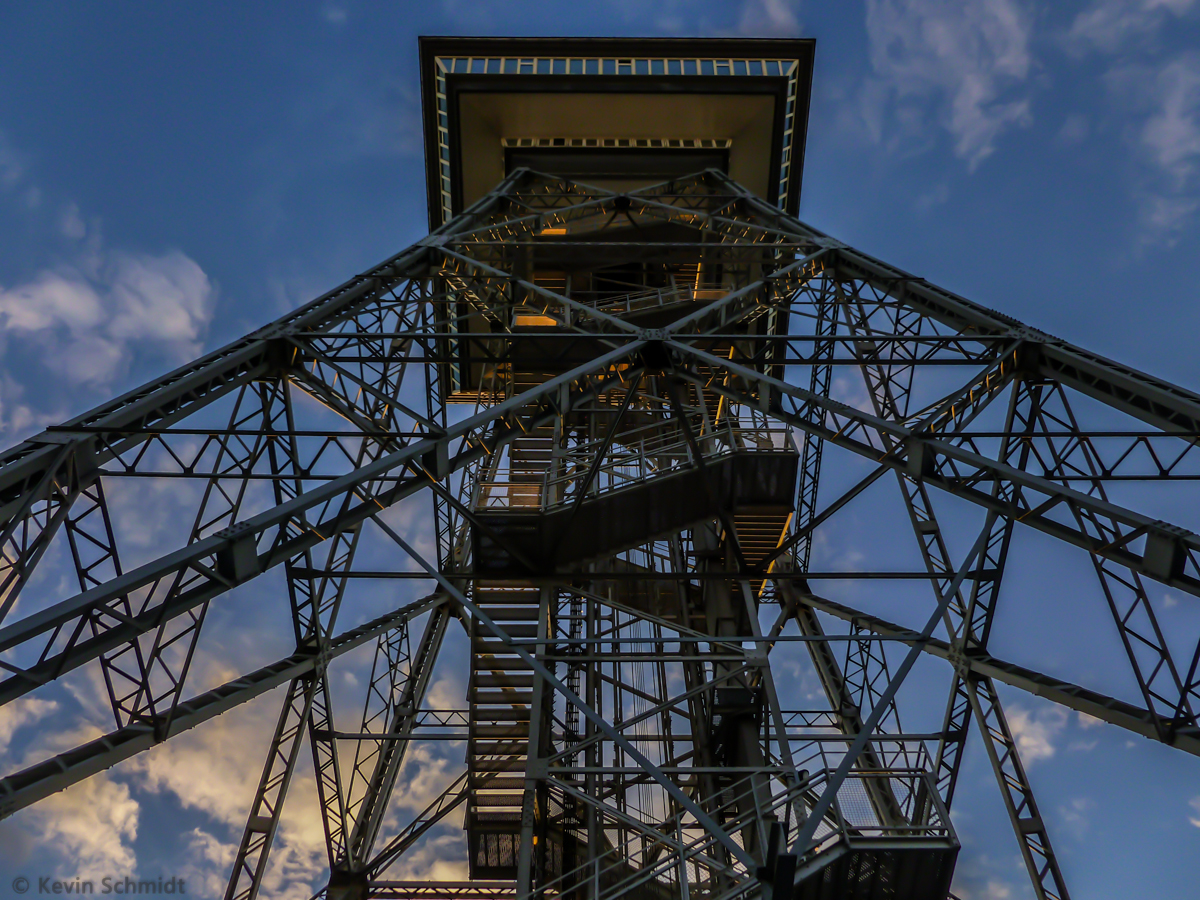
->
0 170 1200 898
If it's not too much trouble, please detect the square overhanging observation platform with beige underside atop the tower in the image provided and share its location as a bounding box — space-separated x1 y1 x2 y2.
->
420 37 816 232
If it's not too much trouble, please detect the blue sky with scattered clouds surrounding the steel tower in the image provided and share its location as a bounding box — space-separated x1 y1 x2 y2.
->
0 0 1200 900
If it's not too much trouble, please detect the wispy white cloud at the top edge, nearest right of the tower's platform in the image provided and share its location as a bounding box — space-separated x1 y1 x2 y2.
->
863 0 1033 170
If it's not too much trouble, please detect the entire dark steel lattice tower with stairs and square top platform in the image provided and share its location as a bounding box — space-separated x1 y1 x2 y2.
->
0 38 1200 900
